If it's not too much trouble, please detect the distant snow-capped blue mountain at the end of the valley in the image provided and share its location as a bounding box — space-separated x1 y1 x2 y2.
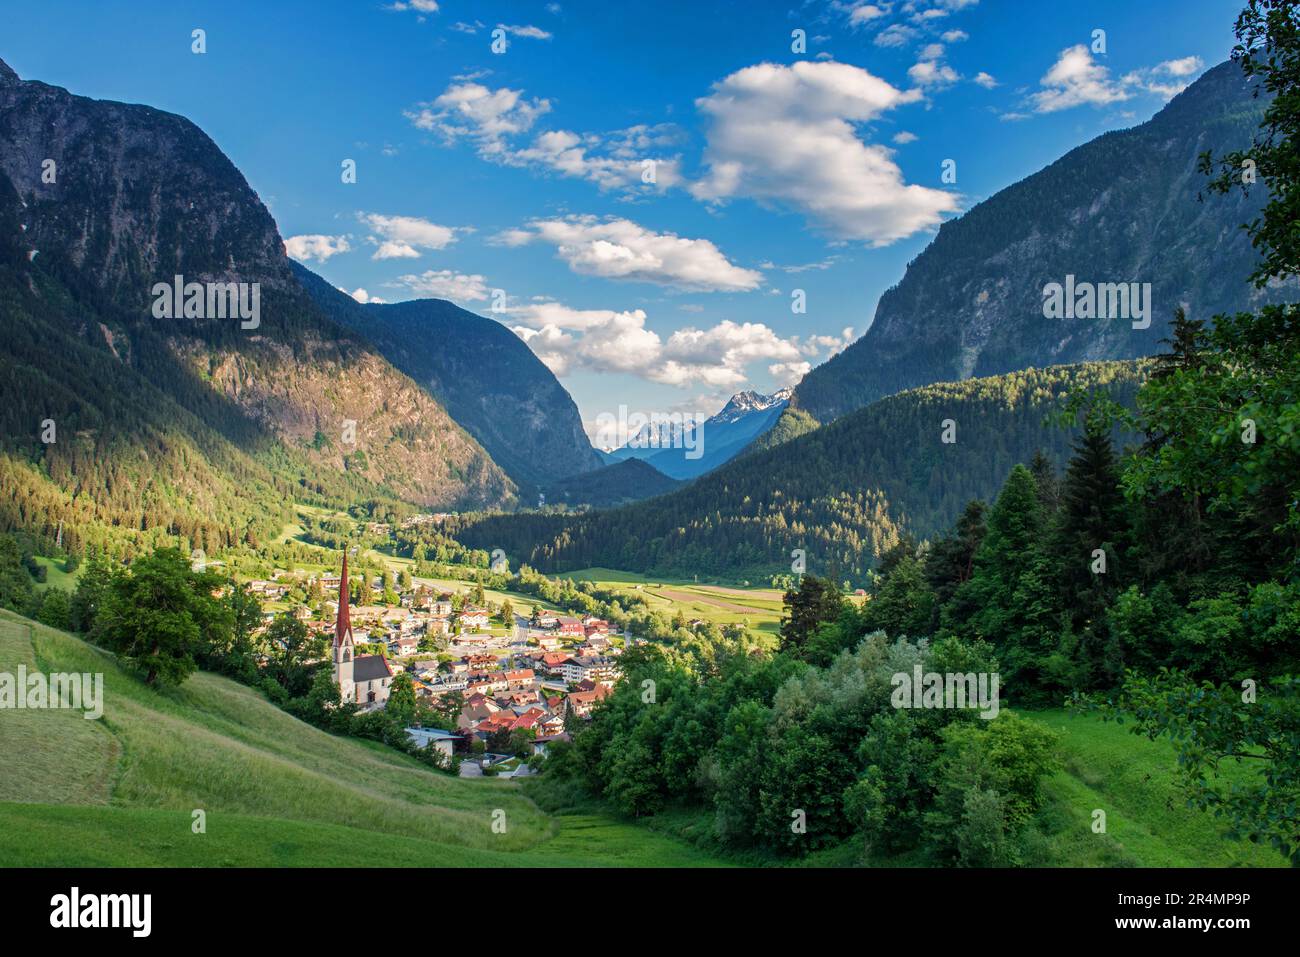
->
607 389 790 479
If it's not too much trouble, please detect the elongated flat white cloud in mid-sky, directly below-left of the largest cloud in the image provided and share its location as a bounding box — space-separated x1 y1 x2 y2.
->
497 216 763 293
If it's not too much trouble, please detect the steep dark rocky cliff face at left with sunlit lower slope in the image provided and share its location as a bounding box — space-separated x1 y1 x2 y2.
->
0 54 515 507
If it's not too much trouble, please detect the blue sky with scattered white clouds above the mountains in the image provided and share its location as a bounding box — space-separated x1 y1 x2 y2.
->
0 0 1240 439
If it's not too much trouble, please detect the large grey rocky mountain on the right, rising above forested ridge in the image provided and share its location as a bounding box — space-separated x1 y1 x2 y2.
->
793 62 1281 421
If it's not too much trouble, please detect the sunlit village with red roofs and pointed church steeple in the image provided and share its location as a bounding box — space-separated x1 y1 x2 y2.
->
248 555 636 778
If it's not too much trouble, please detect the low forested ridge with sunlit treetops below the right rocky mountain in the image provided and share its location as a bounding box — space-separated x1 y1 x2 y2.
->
447 361 1143 581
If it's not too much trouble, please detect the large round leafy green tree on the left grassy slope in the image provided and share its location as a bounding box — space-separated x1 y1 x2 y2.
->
91 549 231 685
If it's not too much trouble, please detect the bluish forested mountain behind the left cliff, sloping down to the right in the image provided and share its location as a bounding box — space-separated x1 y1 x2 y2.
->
294 263 602 486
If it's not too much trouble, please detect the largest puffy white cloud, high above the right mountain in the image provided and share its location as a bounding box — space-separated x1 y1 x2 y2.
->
692 61 957 246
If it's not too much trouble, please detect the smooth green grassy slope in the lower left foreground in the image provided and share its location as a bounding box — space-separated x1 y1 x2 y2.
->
0 612 716 866
